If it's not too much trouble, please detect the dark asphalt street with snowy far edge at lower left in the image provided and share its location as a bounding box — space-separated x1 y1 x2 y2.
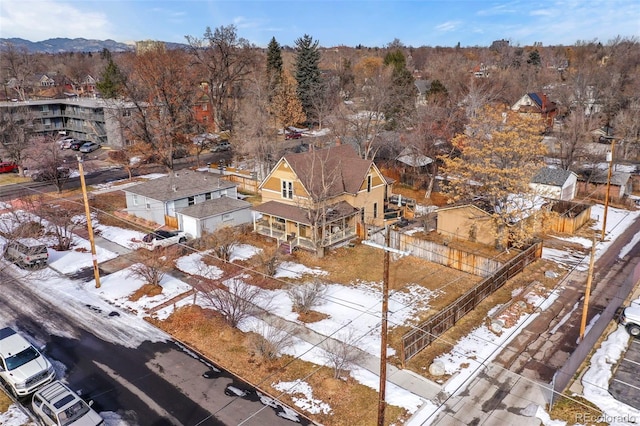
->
0 271 310 426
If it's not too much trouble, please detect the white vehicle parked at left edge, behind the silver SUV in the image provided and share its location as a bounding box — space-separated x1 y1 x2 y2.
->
0 327 56 397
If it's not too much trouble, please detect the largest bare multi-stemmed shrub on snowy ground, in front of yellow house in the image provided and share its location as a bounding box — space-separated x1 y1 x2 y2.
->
204 278 264 327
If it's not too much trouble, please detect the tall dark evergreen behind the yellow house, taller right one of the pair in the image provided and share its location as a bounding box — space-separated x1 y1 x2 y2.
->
295 34 321 118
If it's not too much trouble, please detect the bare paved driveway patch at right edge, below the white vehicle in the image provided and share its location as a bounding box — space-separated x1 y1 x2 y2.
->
609 338 640 409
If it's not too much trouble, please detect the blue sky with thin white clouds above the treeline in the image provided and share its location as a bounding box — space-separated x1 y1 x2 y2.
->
0 0 640 47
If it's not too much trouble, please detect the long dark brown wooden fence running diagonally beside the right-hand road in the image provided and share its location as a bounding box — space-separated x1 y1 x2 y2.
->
401 242 542 365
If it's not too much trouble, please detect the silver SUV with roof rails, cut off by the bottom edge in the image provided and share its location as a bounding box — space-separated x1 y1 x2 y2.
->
31 380 104 426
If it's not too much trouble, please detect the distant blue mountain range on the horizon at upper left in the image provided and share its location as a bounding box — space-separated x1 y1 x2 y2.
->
0 38 188 53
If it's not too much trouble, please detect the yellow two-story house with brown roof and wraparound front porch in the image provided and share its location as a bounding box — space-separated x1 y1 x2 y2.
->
254 145 388 256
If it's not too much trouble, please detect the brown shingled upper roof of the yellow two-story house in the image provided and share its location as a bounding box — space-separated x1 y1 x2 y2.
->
283 145 375 198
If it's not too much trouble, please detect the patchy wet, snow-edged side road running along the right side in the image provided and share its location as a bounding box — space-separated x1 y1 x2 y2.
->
429 215 640 426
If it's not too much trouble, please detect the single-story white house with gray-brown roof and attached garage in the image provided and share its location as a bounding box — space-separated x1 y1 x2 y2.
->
124 170 251 238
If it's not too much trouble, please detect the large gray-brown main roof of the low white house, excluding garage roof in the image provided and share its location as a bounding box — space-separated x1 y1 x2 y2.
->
124 170 236 201
